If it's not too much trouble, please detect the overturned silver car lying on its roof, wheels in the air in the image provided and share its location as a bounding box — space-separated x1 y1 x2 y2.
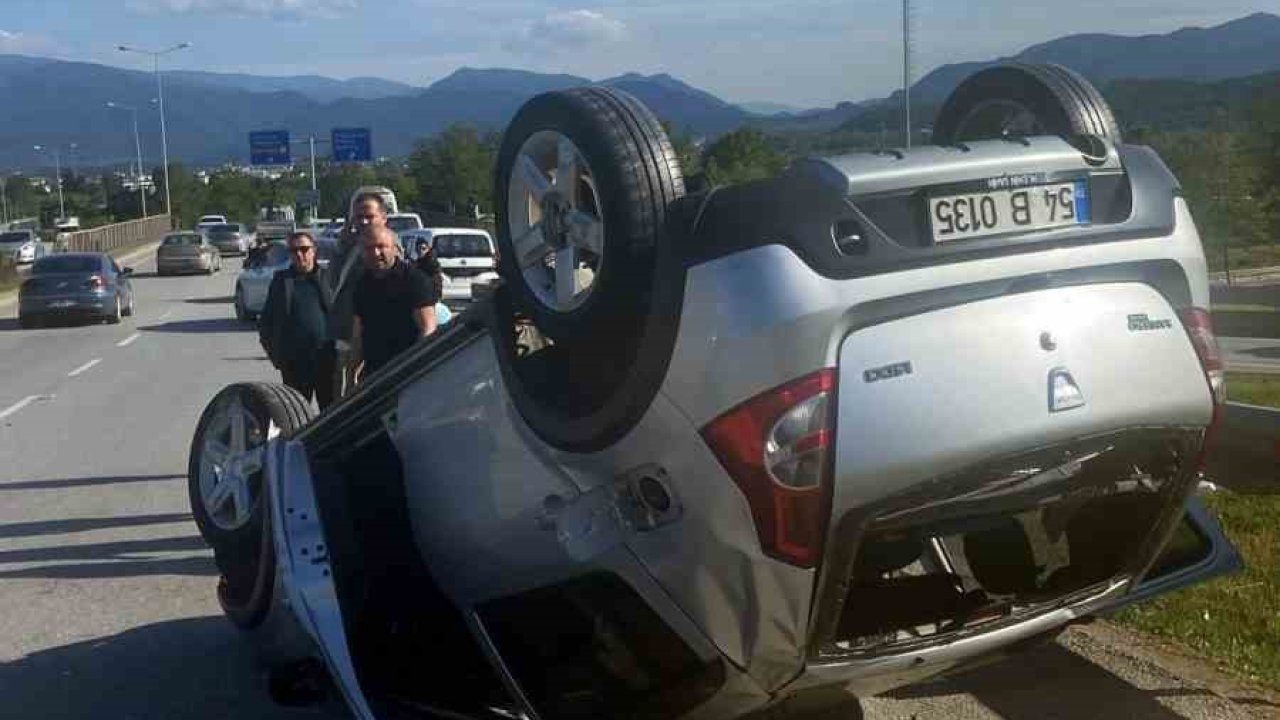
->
188 65 1239 719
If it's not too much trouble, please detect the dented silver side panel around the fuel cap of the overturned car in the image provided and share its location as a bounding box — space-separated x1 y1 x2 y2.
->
396 336 813 688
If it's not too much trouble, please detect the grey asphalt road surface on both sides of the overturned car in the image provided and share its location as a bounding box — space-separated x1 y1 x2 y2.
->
0 254 1280 720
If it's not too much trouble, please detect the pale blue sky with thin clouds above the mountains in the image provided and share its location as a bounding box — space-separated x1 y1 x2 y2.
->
0 0 1280 106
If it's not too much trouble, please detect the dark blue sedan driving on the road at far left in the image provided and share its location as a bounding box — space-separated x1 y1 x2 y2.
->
18 252 133 328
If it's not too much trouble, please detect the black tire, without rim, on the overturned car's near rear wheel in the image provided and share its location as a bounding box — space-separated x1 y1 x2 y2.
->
495 87 685 341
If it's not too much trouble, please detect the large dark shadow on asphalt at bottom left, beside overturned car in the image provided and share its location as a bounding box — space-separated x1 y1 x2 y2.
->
0 618 338 720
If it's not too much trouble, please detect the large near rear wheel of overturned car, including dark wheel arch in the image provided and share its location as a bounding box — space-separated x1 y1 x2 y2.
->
494 87 685 451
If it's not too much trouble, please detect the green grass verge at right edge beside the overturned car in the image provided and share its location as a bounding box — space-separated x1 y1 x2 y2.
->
1115 373 1280 689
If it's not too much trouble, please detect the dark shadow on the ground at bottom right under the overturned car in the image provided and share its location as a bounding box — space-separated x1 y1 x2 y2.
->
890 643 1219 720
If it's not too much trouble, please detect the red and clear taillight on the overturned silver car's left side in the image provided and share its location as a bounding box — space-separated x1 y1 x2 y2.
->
703 368 836 568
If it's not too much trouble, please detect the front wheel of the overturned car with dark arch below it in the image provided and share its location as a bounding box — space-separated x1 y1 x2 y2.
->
187 383 314 629
